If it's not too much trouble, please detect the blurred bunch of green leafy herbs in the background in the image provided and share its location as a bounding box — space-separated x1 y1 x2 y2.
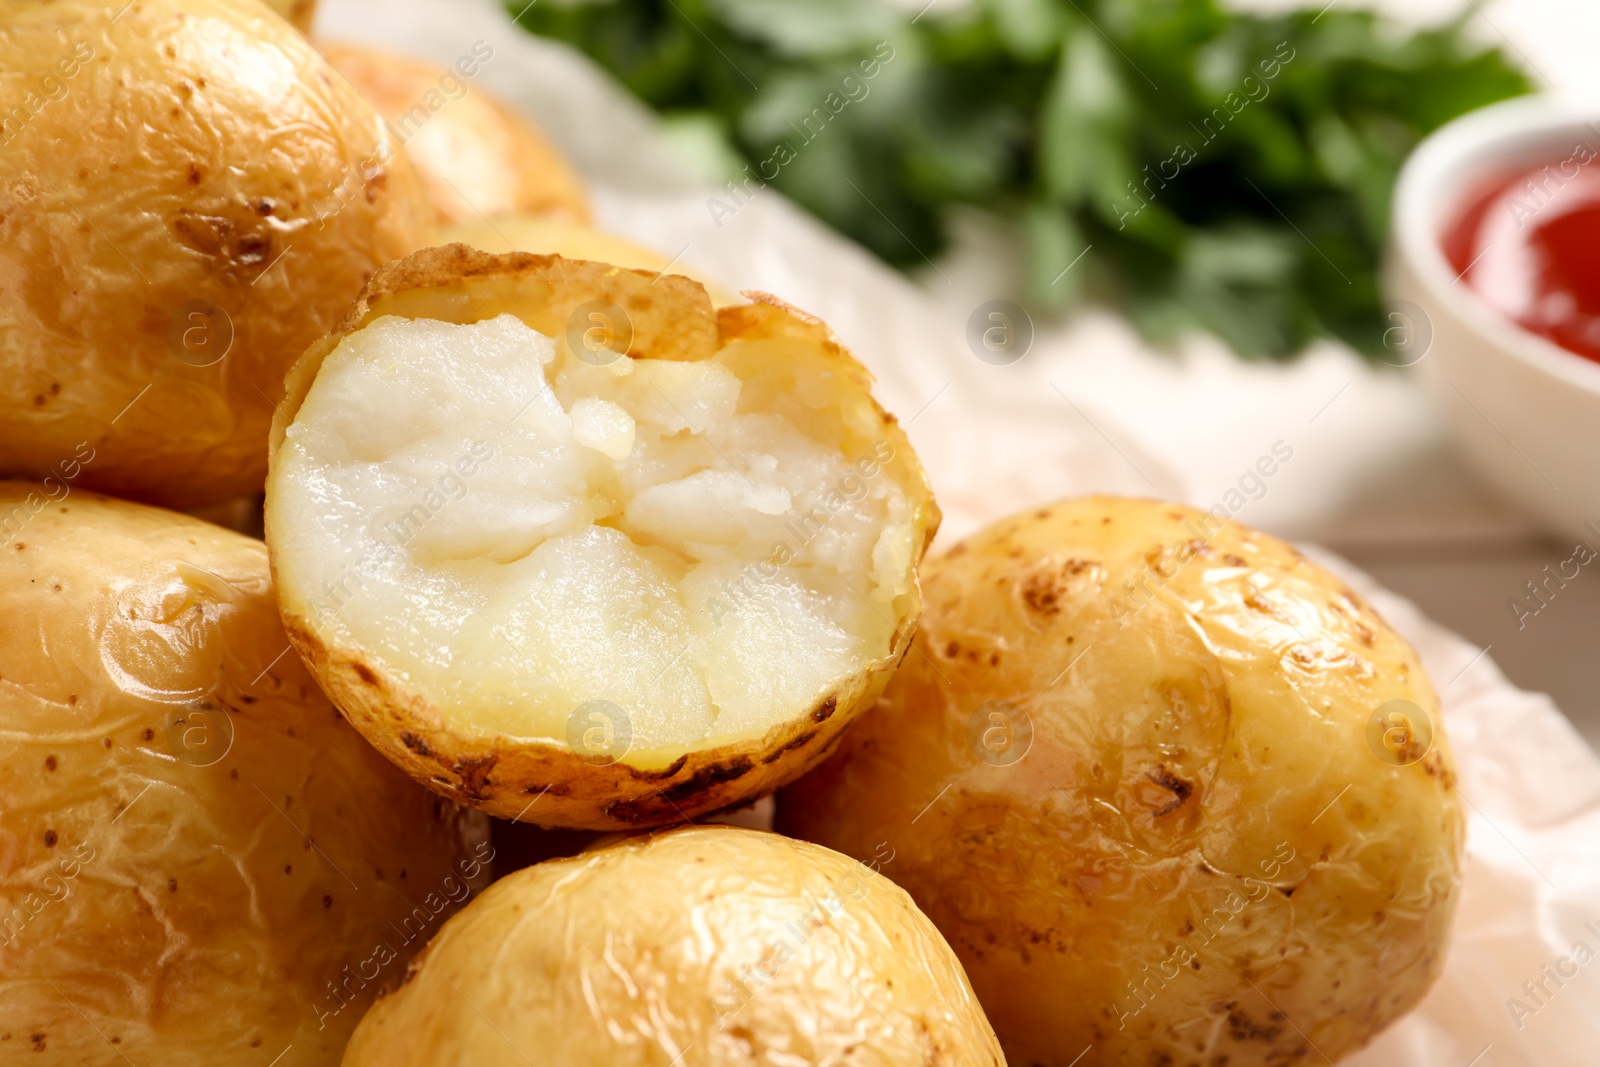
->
512 0 1531 358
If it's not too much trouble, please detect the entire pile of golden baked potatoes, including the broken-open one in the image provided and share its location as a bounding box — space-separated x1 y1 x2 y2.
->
0 0 1462 1067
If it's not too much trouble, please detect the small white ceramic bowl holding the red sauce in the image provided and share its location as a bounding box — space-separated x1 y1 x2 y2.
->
1387 96 1600 542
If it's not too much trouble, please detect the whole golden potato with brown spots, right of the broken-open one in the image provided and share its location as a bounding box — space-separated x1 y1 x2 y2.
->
778 498 1464 1067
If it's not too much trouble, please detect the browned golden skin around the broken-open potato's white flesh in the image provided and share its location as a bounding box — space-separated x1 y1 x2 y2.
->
266 245 939 830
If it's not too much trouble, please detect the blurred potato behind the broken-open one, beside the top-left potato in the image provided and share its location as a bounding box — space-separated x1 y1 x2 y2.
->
322 42 589 224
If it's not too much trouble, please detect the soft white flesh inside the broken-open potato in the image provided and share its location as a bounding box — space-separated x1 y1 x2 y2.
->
274 315 918 761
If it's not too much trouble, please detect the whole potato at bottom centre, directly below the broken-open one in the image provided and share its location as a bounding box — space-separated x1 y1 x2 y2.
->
344 827 1005 1067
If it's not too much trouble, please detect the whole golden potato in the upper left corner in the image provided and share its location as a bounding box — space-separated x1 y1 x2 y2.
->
0 0 432 509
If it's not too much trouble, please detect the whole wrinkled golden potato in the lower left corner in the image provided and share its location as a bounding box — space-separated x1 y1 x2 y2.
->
0 482 491 1067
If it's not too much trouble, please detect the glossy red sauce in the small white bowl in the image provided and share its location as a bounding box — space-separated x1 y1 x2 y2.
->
1442 144 1600 362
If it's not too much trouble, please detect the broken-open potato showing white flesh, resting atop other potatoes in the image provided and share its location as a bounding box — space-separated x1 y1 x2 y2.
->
266 245 938 830
